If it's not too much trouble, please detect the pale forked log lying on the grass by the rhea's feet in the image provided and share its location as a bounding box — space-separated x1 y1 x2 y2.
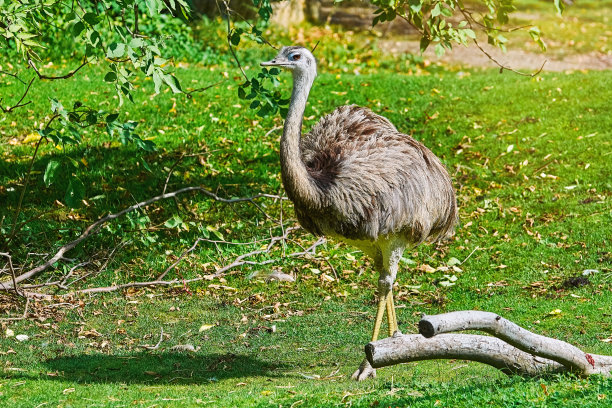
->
365 311 612 376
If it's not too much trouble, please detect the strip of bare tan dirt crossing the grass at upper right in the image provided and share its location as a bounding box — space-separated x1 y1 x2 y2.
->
378 40 612 71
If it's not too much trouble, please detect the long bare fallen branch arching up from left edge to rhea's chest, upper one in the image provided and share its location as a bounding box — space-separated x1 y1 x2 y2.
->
0 187 284 290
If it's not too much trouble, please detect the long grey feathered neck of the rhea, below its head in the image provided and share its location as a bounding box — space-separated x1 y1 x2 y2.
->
280 72 320 207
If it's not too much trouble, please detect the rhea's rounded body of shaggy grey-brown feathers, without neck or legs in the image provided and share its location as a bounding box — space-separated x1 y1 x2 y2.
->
288 105 456 246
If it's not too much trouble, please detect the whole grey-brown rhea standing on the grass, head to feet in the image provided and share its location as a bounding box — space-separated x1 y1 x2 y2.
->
261 46 457 381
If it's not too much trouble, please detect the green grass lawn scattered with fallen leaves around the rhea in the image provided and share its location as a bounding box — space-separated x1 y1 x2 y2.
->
0 56 612 407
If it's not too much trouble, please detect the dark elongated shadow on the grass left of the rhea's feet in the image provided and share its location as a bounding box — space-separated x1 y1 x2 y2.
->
34 352 290 385
